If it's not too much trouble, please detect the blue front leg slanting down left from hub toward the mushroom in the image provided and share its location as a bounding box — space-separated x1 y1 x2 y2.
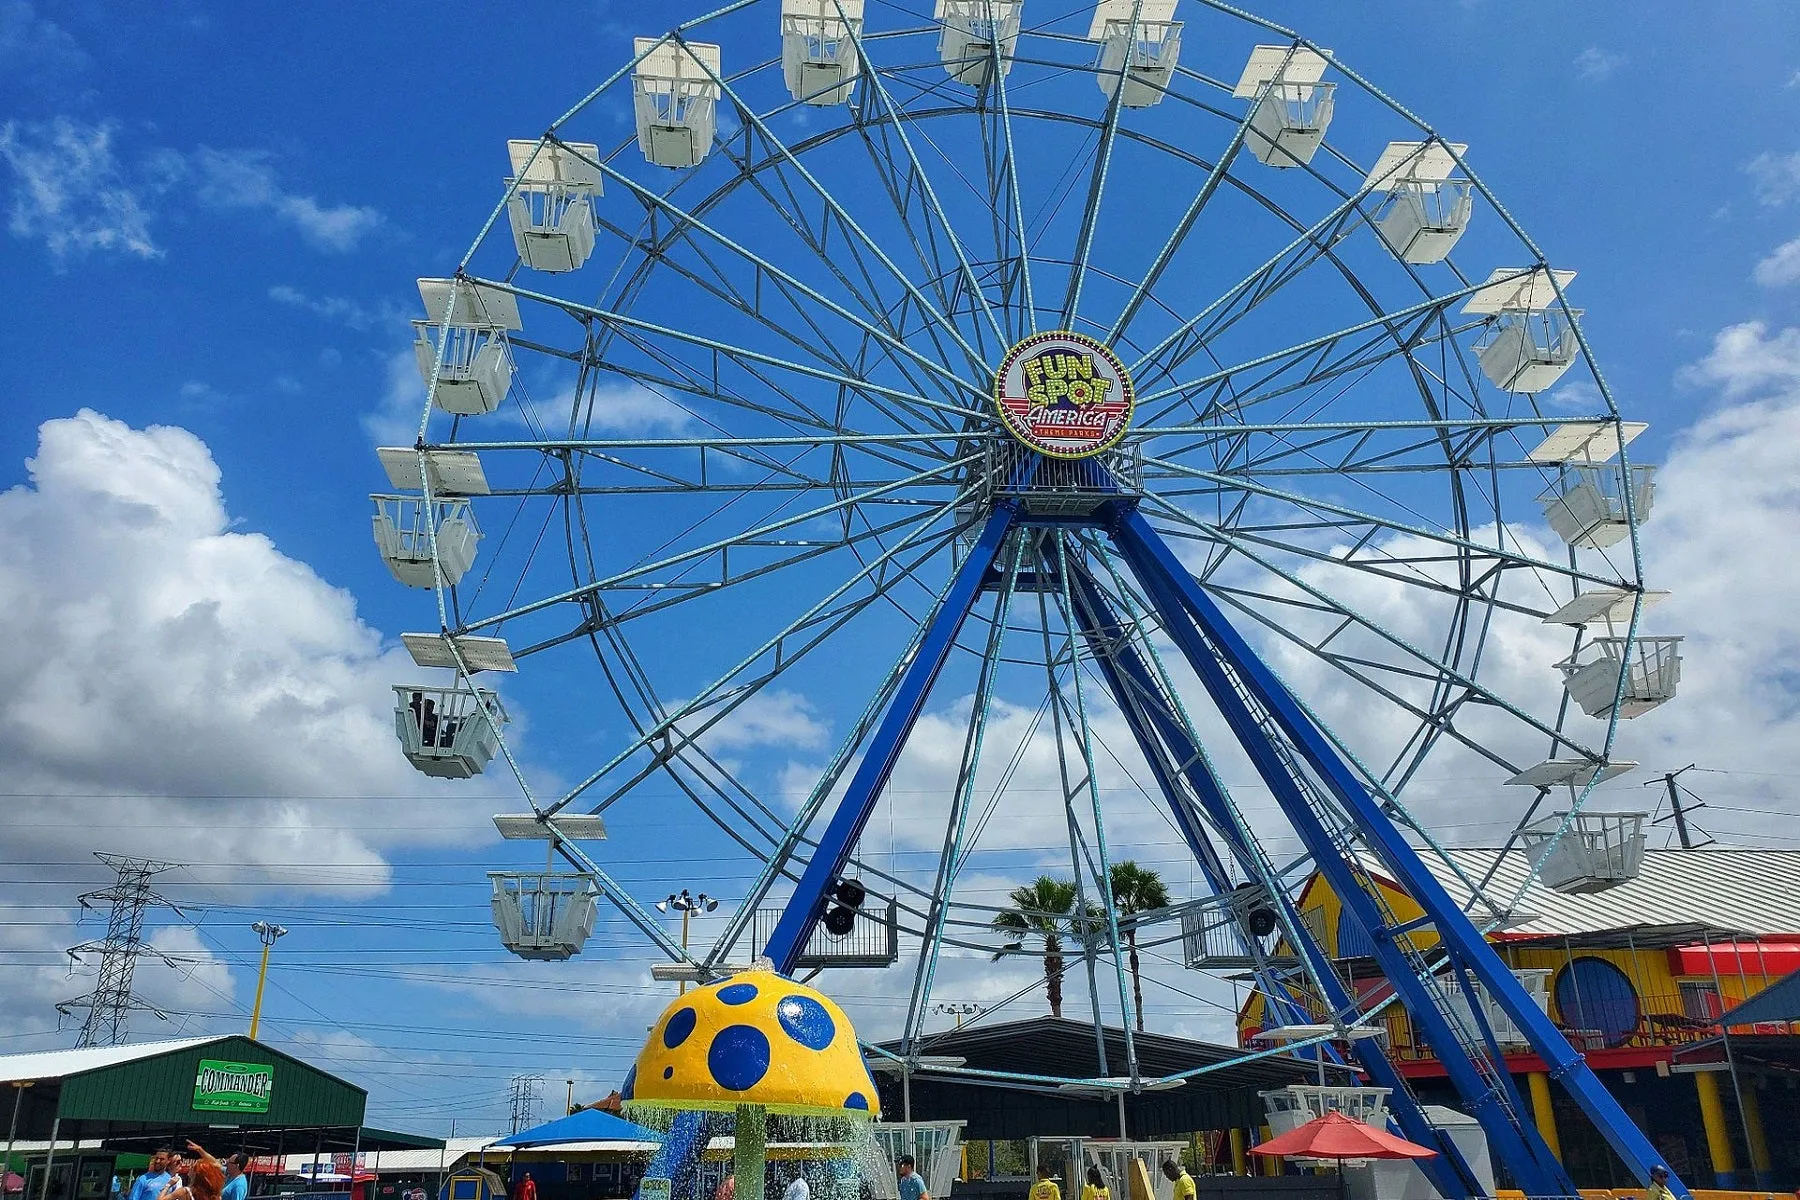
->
763 504 1019 975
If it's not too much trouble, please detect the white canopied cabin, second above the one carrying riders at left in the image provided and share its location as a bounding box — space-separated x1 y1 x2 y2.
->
412 279 524 417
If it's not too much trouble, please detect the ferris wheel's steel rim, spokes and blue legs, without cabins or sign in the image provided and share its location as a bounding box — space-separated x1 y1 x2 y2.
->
383 0 1683 1195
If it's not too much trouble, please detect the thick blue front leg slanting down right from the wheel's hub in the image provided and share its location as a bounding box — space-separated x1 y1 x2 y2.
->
1114 511 1687 1196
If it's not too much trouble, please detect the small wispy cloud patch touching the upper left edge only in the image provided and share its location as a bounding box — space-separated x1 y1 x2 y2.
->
0 117 162 259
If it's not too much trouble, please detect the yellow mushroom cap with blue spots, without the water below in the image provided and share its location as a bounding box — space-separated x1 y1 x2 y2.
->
619 970 880 1119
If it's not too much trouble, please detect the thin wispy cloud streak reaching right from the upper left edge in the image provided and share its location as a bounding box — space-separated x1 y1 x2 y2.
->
0 118 382 259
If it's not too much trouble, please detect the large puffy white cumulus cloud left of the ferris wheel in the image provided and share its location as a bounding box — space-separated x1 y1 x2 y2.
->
0 410 500 1018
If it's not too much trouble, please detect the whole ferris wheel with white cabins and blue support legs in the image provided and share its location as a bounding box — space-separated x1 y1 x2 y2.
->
374 0 1681 1195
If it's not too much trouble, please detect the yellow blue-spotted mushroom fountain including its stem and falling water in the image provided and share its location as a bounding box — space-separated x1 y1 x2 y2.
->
621 968 887 1200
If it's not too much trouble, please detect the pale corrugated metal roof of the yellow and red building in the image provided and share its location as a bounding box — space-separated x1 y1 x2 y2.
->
1396 847 1800 937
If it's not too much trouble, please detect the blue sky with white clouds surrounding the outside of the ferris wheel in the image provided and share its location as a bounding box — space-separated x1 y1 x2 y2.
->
0 0 1800 1132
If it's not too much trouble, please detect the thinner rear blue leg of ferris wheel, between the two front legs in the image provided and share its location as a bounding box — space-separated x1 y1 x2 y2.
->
1071 569 1485 1196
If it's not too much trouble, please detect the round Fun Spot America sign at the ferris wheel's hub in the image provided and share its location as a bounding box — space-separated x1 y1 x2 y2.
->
994 329 1138 459
